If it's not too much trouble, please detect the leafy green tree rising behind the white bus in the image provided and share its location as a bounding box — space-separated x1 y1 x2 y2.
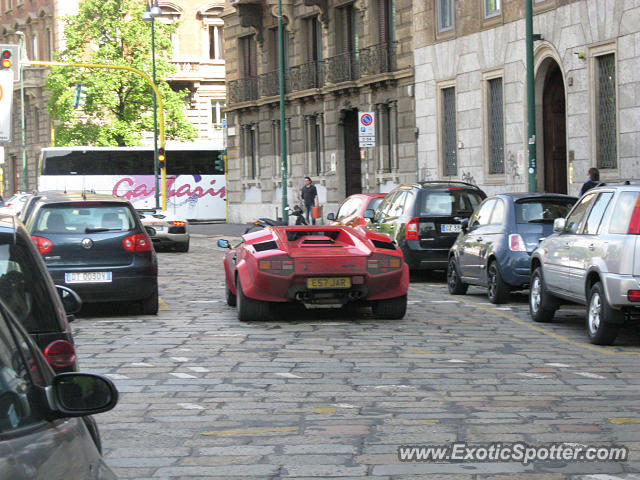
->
47 0 197 146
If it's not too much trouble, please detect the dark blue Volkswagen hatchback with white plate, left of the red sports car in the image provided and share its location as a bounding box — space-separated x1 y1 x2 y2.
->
26 192 158 315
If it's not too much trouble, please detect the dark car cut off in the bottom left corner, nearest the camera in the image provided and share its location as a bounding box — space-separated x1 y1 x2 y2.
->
0 300 118 480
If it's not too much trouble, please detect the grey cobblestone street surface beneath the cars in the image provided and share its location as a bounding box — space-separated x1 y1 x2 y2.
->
72 235 640 480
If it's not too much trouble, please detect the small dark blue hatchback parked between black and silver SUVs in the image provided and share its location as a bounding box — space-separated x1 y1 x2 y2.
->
447 193 577 303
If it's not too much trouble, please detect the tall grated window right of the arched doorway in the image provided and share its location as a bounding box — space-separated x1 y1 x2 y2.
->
596 53 618 168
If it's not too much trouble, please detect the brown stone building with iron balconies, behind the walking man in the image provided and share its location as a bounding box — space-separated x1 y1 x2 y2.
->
223 0 416 222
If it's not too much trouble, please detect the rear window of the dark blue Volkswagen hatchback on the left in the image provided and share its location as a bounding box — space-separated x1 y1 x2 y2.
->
31 202 135 234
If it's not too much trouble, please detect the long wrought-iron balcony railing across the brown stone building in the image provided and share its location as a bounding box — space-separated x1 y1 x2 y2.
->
227 42 397 104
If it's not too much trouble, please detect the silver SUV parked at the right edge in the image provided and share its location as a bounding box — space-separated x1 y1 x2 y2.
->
529 182 640 345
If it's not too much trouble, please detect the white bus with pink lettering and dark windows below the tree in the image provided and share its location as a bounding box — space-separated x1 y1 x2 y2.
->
38 145 227 220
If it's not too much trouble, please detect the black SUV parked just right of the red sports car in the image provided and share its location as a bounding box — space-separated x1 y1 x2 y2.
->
365 181 487 270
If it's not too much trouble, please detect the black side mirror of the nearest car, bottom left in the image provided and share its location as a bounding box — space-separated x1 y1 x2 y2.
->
48 372 118 418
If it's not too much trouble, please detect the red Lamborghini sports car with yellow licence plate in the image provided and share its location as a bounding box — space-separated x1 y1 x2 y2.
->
218 225 409 321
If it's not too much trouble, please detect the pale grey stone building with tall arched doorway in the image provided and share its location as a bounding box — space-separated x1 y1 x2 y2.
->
413 0 640 194
